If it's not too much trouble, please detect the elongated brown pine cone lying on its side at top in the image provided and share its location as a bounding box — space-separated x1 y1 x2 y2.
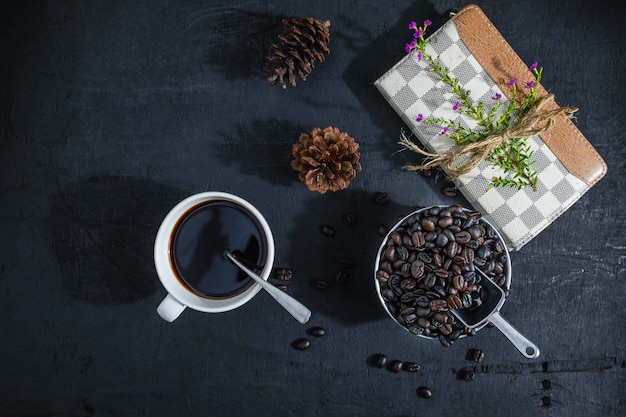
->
265 17 330 88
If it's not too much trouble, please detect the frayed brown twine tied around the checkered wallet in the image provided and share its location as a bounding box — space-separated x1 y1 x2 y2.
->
399 94 578 179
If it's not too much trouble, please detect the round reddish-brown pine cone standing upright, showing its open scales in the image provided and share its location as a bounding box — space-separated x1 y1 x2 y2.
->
291 126 361 194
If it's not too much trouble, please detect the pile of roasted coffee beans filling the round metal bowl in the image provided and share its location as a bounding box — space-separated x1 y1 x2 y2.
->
376 204 508 346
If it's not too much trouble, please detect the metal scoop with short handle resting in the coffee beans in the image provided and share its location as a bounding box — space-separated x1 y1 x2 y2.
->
450 268 539 359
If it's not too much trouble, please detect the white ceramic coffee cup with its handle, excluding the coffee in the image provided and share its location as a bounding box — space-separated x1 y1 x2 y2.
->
154 191 274 322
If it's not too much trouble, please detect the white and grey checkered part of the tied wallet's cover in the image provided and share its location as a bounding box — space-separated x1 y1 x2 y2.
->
375 20 589 250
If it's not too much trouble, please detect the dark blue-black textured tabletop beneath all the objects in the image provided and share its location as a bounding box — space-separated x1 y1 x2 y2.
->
0 0 626 417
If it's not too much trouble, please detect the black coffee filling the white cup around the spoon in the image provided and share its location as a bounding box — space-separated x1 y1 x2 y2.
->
170 199 267 299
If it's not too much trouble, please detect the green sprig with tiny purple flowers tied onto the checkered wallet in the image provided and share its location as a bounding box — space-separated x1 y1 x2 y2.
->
401 20 544 190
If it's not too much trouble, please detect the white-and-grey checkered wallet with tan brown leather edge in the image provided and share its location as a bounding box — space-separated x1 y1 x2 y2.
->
375 5 606 249
